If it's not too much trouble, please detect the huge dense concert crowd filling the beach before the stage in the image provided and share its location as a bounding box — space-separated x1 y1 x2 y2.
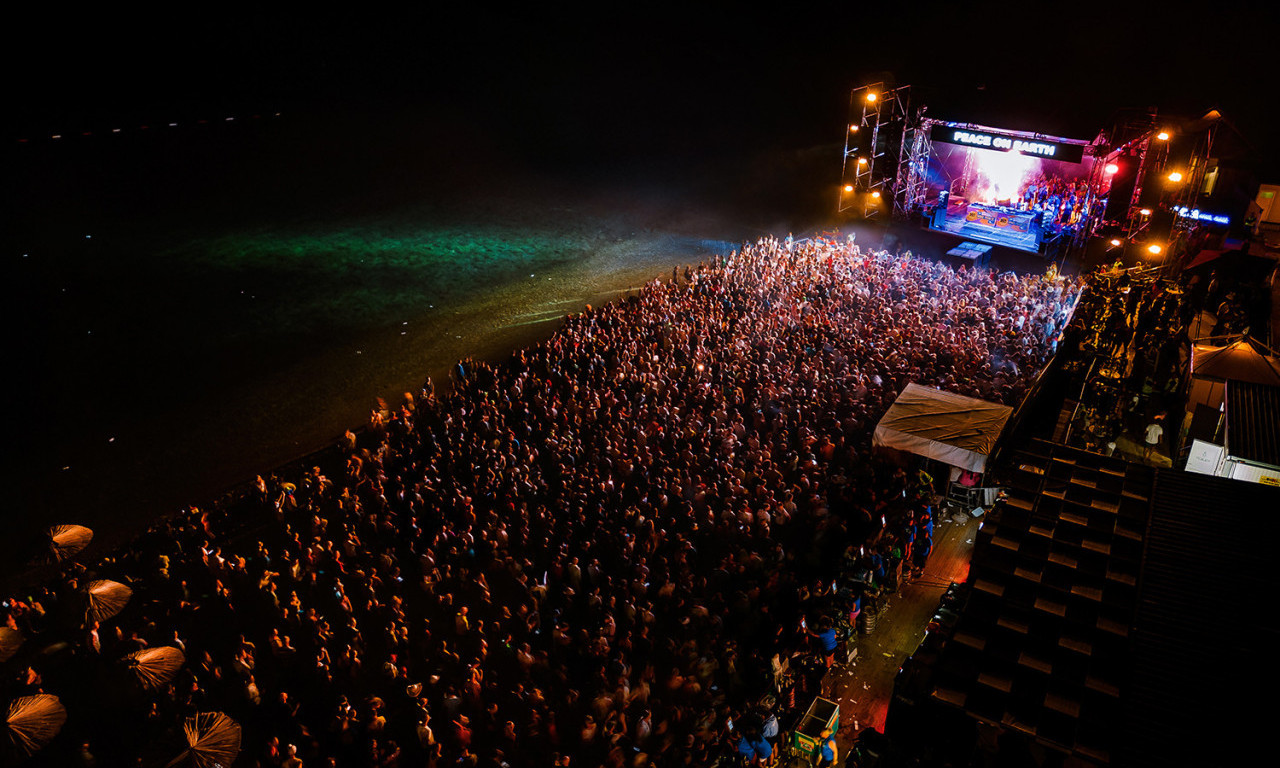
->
4 238 1080 768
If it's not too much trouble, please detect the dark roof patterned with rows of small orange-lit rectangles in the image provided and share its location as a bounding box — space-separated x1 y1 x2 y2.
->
932 443 1153 764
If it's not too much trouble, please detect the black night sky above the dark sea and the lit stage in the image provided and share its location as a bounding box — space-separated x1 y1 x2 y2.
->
4 3 1280 171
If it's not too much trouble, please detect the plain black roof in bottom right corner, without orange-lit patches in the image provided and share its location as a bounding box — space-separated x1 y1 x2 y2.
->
1116 470 1280 765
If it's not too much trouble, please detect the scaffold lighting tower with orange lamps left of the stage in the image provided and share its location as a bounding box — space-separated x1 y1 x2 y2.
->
838 83 911 218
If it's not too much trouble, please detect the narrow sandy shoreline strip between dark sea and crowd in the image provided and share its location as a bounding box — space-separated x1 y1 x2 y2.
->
0 221 742 589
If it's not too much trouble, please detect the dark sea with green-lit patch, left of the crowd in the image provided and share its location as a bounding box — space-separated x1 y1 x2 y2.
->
0 104 840 577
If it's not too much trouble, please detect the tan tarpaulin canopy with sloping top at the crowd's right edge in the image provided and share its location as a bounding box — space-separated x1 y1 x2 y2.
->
872 384 1014 472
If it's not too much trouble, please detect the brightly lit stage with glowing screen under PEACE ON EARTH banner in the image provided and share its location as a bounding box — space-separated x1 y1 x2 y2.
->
925 123 1106 252
